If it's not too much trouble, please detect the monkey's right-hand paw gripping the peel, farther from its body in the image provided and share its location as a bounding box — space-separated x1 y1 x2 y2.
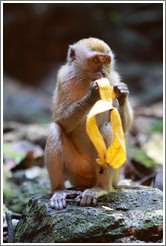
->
114 83 129 106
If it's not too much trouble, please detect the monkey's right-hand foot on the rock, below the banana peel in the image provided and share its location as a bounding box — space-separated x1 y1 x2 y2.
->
80 187 108 207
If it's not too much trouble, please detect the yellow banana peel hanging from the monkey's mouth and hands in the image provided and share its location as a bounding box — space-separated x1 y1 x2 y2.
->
86 78 126 170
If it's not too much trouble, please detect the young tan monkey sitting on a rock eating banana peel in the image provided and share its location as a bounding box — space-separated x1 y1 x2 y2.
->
45 37 133 209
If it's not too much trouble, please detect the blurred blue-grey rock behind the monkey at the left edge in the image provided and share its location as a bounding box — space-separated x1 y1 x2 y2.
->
3 76 51 123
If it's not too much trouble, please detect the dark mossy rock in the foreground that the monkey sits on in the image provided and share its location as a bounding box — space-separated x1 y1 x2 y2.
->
15 186 163 243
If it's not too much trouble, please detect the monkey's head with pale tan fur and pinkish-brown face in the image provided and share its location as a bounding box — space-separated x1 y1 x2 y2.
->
67 38 113 82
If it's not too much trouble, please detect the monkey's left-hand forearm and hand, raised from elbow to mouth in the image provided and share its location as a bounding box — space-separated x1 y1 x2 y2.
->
54 82 100 133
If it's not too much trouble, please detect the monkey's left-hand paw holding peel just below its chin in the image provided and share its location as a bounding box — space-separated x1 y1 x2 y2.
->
87 81 100 104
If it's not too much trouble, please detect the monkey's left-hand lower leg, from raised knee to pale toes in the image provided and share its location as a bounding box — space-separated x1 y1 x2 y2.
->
45 123 80 209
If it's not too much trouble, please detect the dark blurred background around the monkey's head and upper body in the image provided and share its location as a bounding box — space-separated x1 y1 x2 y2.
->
3 3 163 123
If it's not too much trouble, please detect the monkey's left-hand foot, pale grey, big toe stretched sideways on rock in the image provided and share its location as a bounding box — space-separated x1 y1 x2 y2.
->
50 190 82 210
